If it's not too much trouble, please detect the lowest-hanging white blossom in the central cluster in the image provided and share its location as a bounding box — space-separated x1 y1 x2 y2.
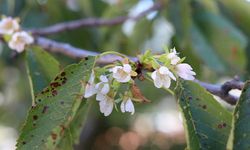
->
99 95 114 116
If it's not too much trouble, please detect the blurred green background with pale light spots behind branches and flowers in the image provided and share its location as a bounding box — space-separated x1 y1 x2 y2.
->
0 0 250 150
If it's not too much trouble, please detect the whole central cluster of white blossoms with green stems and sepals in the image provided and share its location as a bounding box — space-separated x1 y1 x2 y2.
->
84 49 195 116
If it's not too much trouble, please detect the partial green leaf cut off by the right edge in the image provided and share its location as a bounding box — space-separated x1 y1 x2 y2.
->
227 81 250 150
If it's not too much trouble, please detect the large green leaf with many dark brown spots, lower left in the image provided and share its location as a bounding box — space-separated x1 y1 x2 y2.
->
17 57 95 150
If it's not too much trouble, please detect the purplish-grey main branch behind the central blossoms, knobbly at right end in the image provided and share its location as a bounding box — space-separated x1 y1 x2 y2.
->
35 37 244 105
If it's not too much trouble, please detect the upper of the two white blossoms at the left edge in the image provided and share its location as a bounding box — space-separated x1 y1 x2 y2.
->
0 17 19 35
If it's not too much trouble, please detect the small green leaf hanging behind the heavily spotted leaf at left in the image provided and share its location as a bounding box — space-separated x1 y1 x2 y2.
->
26 46 60 101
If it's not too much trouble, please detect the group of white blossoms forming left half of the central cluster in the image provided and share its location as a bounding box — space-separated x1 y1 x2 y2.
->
84 64 136 116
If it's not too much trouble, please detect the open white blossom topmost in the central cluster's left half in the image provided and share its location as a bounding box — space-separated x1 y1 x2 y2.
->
112 64 137 83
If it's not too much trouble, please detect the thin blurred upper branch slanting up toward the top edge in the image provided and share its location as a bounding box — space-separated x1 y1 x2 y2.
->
29 2 162 35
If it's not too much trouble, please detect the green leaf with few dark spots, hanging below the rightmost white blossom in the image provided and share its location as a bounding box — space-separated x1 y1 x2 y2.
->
176 81 232 150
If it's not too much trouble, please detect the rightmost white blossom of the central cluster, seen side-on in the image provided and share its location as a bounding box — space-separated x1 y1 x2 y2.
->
176 63 196 80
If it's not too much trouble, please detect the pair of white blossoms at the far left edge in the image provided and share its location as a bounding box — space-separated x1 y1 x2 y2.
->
0 17 34 53
